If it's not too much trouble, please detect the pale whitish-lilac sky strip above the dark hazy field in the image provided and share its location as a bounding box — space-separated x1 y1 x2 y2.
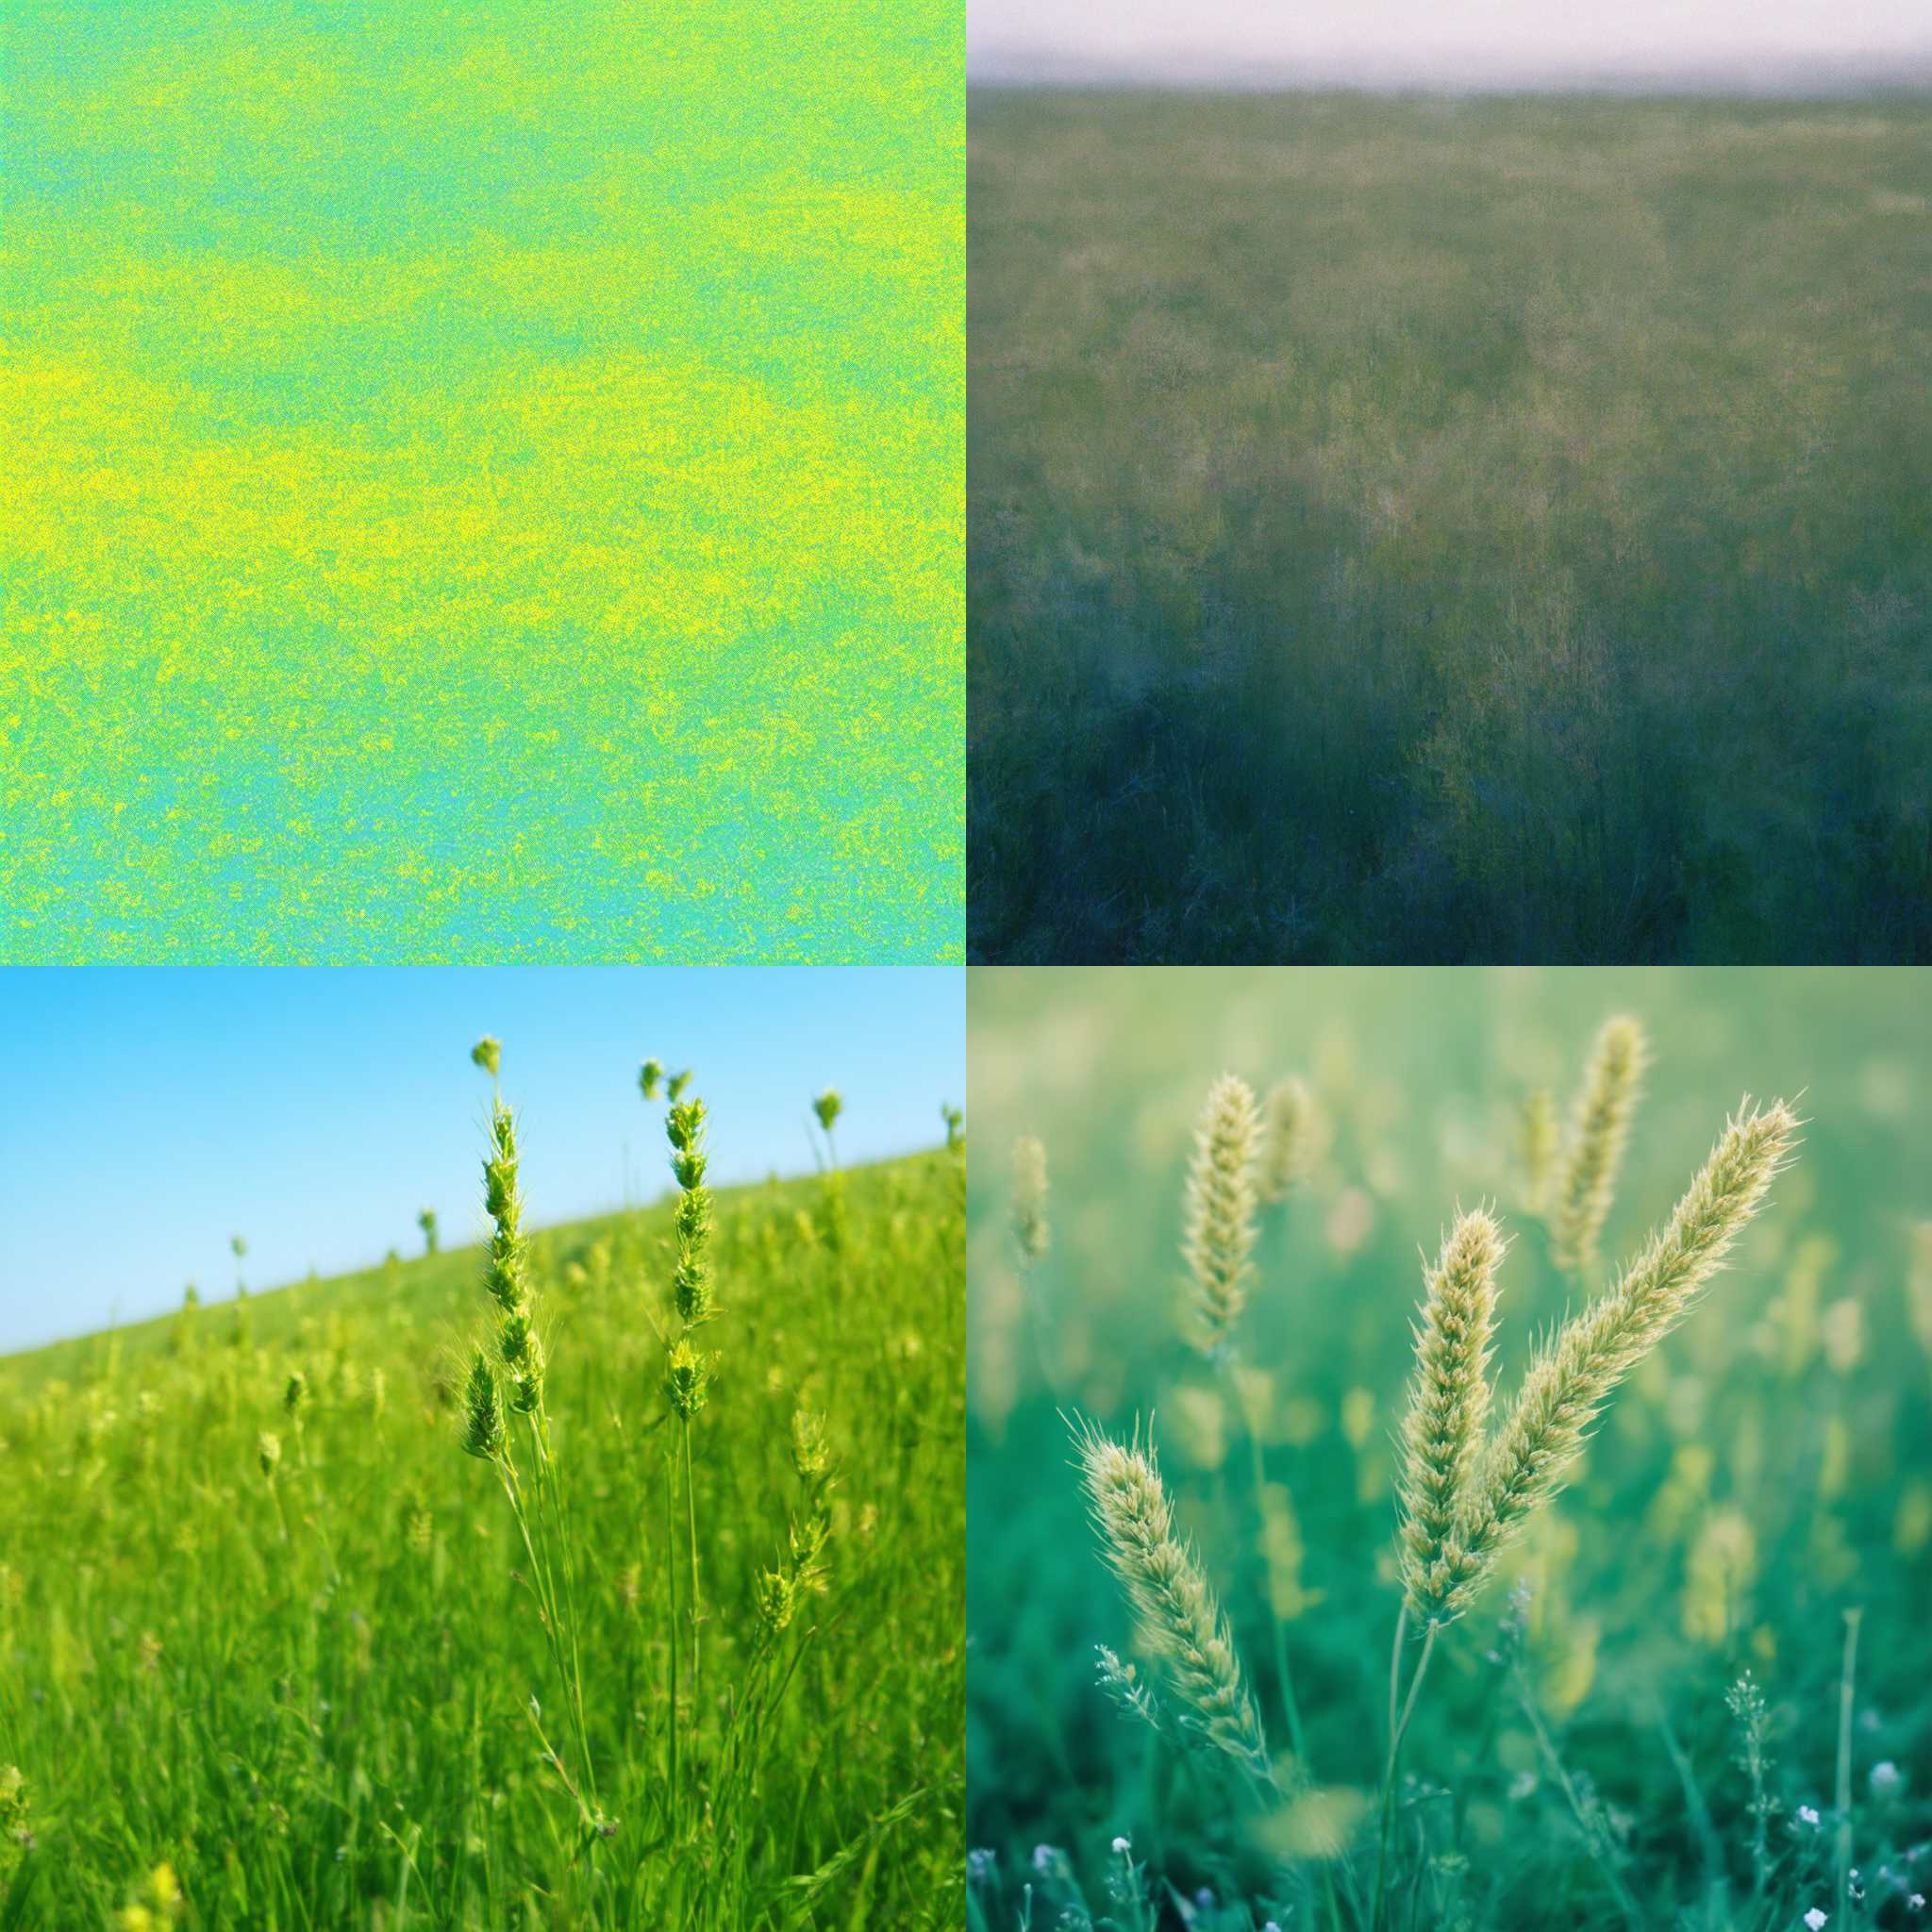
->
966 0 1932 85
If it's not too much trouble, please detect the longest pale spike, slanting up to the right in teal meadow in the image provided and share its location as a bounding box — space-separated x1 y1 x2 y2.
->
1438 1101 1799 1615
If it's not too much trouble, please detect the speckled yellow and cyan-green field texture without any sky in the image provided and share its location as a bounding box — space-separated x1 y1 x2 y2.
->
0 0 964 962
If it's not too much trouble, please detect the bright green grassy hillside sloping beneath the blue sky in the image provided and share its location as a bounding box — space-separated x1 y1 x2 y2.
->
0 1081 964 1932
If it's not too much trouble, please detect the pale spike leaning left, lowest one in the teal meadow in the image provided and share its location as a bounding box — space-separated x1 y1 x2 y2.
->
1071 1422 1267 1775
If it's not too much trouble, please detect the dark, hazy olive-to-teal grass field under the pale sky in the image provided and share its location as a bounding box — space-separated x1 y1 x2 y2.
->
968 91 1932 964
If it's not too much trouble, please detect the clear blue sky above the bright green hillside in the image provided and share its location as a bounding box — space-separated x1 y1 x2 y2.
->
0 966 966 1353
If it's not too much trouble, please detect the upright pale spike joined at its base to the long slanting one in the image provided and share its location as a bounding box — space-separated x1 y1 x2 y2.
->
1399 1211 1503 1619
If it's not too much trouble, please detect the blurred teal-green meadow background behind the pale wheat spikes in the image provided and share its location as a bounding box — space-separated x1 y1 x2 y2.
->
968 970 1932 1932
